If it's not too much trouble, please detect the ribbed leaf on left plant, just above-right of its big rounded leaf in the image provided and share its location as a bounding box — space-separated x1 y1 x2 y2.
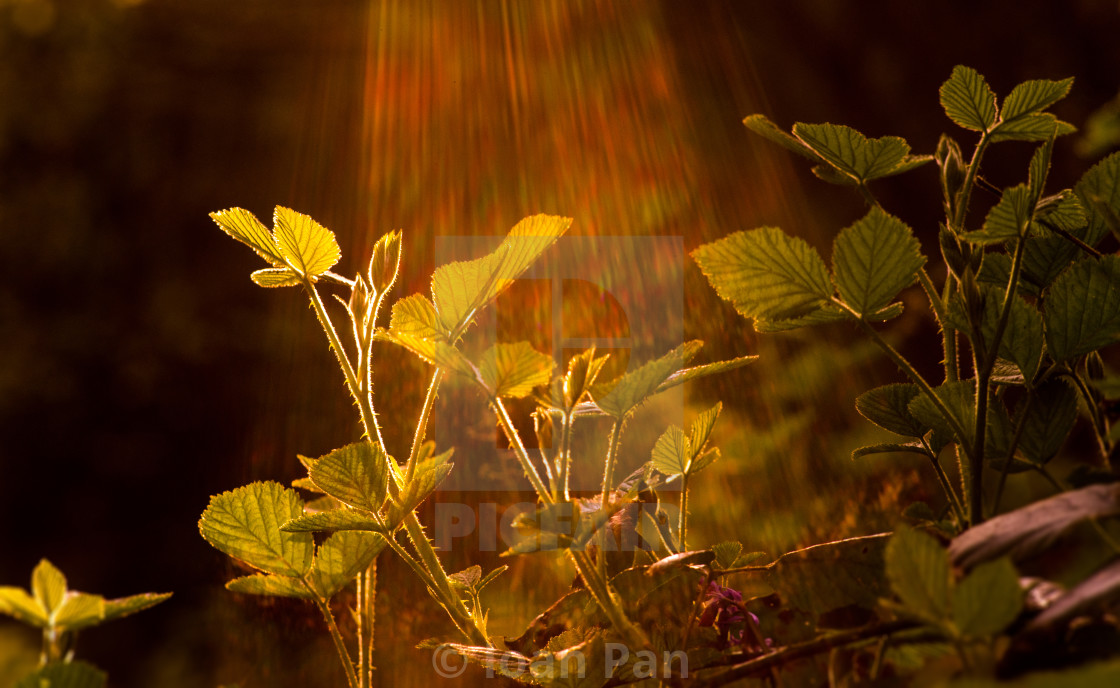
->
309 441 392 515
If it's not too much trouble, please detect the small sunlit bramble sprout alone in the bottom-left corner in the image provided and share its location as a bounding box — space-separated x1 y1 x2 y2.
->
0 559 171 688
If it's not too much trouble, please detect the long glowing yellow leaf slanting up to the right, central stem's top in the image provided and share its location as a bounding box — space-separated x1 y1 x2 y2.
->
431 215 571 337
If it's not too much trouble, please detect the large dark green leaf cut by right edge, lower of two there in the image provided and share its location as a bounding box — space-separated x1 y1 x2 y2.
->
1043 255 1120 362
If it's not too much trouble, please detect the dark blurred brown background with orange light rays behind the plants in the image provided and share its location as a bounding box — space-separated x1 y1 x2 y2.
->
0 0 1120 688
